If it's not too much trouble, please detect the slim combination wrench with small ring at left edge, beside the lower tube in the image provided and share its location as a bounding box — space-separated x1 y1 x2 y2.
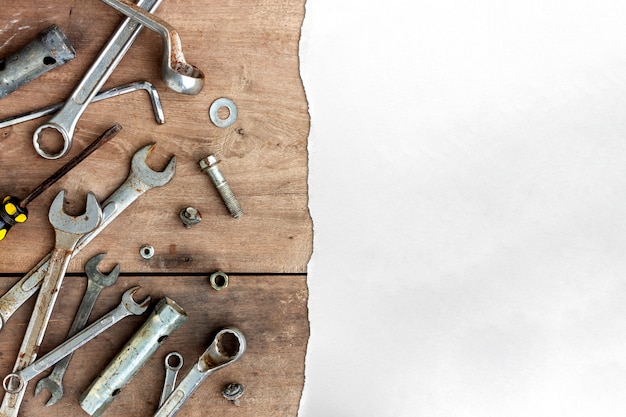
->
2 287 150 394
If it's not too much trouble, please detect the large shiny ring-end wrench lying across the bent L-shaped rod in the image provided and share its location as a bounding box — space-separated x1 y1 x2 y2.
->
33 0 161 159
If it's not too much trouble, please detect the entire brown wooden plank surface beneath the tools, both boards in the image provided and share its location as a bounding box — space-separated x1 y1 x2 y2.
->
0 0 312 417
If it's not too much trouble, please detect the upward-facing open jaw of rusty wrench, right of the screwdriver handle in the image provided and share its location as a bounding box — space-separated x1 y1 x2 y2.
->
48 190 102 235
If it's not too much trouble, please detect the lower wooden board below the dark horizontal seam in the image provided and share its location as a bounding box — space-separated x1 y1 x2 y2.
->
0 275 308 417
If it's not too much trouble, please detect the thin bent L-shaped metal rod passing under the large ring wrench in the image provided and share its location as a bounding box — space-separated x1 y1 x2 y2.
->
0 81 165 129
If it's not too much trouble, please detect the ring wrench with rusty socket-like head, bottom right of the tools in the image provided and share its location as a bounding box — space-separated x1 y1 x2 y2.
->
154 327 246 417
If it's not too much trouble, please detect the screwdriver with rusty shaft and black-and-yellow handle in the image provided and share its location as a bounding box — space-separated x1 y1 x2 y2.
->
0 124 122 240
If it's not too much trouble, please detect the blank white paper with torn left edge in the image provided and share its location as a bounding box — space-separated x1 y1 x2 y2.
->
299 0 626 417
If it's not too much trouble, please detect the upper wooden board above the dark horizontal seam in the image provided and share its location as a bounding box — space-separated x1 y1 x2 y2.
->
0 0 312 273
